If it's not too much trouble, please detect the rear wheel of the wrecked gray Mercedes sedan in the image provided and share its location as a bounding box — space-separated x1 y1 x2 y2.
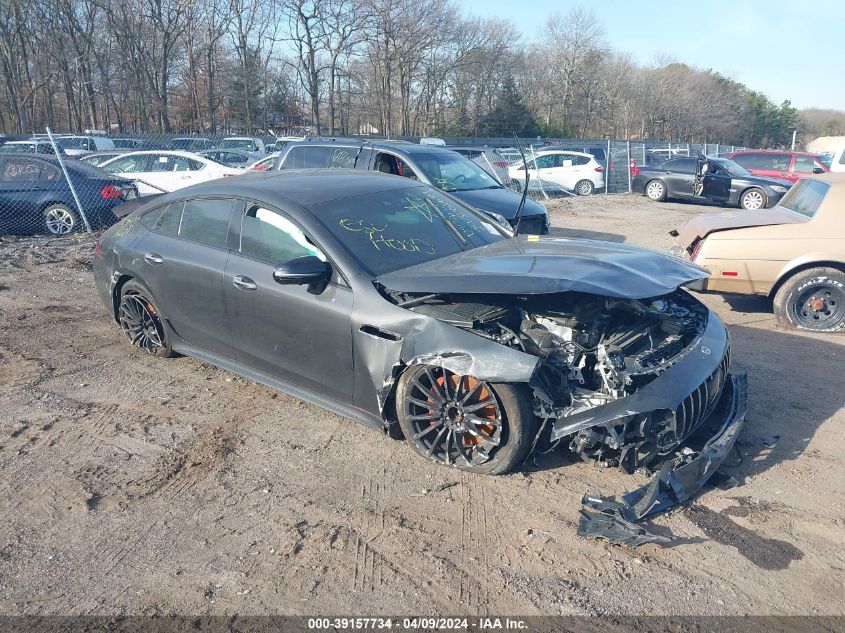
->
117 279 176 358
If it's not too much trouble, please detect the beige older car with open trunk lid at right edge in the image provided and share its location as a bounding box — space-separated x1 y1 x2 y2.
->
671 174 845 332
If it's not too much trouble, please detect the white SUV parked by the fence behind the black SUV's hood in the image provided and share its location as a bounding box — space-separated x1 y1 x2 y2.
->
508 150 604 196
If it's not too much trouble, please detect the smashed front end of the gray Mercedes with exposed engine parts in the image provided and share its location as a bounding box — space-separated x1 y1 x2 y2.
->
386 289 746 542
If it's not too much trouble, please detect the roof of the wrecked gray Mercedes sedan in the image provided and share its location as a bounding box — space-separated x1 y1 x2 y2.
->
158 169 428 207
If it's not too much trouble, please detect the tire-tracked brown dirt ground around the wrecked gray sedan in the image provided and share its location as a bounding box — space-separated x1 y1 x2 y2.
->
0 195 845 615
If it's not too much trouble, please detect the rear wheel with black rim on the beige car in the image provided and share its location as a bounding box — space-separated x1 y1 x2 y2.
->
772 268 845 332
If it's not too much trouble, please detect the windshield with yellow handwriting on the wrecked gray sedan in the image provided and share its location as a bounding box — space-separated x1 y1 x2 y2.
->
311 187 508 277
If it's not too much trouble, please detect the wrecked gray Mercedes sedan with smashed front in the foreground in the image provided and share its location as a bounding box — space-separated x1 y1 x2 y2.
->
94 170 745 508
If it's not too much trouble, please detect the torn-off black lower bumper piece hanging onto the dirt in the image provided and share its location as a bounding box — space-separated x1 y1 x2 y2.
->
578 374 748 547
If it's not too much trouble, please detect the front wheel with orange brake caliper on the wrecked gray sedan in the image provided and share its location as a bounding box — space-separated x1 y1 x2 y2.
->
396 365 537 475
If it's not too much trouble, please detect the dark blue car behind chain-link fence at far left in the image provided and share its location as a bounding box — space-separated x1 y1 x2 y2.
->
0 154 137 235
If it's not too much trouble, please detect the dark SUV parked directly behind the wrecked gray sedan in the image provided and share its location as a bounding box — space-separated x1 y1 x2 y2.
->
273 138 549 234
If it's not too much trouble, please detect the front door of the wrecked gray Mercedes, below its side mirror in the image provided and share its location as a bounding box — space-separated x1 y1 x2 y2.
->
224 203 353 404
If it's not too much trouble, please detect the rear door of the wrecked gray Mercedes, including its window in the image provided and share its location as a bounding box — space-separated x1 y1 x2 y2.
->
136 198 240 358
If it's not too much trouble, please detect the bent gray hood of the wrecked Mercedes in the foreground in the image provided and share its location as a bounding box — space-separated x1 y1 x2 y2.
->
376 235 709 299
